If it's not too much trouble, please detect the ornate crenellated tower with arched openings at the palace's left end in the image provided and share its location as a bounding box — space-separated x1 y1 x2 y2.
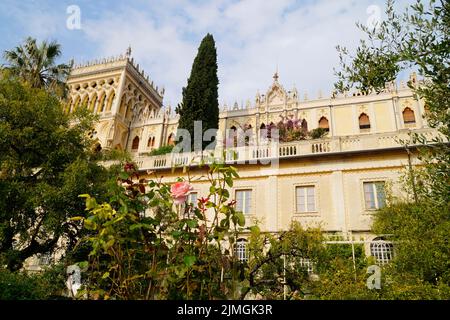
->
67 48 164 149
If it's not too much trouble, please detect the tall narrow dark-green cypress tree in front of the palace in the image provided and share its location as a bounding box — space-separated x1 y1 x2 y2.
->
176 33 219 150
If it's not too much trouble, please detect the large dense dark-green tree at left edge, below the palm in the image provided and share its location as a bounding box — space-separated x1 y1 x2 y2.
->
0 75 109 270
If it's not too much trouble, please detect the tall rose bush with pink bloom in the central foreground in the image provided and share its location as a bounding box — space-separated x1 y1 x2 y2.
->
73 164 256 299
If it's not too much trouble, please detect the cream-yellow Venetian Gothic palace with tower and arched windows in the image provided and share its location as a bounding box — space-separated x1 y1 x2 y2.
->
61 50 437 263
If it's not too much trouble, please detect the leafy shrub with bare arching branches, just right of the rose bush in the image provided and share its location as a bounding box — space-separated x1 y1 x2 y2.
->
241 223 325 299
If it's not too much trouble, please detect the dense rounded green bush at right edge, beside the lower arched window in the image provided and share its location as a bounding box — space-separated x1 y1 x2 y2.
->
374 202 450 286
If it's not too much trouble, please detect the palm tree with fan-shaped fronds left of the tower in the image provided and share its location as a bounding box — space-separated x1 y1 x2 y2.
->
4 37 72 96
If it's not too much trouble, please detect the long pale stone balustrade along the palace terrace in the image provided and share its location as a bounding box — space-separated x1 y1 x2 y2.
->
127 129 437 170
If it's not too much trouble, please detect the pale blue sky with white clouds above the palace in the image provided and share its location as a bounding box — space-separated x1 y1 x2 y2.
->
0 0 411 107
